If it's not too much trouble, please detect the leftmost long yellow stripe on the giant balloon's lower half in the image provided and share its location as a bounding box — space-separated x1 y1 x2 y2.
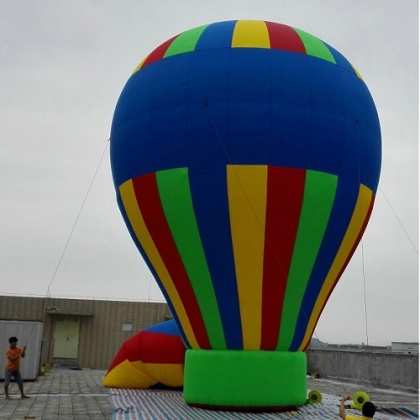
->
116 179 200 349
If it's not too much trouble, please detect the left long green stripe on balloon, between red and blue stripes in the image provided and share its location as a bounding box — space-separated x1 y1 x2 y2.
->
156 168 226 349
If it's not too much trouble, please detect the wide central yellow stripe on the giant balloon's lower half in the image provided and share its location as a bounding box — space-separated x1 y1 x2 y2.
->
227 165 267 350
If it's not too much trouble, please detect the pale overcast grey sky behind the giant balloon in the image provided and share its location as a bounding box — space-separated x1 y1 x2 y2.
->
0 0 419 344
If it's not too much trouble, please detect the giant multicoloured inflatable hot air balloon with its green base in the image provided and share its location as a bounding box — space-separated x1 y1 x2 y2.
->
111 20 381 410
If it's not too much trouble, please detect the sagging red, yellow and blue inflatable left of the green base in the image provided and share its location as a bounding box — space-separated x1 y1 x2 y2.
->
103 320 186 389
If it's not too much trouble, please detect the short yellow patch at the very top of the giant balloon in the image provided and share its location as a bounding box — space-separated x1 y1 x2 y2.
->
232 20 270 48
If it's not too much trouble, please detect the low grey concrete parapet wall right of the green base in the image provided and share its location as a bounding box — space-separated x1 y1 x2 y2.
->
306 349 419 390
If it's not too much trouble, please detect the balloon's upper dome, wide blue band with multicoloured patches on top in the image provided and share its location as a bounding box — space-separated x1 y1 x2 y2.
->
111 21 381 191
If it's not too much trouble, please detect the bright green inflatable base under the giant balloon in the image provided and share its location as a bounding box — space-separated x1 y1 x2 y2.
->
184 350 307 411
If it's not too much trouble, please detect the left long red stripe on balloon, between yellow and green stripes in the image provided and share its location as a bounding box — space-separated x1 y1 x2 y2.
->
133 173 210 349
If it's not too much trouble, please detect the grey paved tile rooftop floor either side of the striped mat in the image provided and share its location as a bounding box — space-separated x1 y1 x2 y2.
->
0 367 419 420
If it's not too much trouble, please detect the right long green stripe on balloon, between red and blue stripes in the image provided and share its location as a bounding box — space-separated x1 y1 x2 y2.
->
277 171 338 350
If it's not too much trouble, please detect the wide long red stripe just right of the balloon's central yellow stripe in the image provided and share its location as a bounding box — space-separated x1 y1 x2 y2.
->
261 167 306 350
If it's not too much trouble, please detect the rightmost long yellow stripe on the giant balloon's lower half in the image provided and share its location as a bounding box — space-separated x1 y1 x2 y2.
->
298 185 373 351
